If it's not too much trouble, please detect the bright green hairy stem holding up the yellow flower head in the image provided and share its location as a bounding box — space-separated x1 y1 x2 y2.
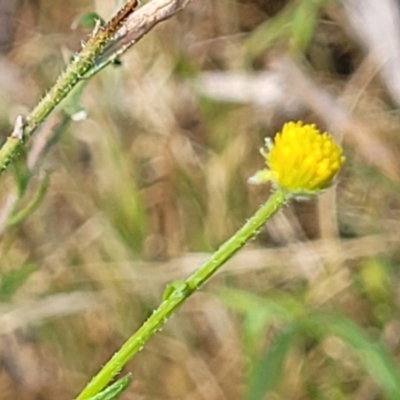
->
76 190 287 400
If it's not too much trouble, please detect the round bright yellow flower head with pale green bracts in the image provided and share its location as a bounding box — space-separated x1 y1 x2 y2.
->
250 121 344 195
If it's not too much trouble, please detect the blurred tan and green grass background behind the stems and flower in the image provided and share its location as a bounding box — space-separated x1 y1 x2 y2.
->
0 0 400 400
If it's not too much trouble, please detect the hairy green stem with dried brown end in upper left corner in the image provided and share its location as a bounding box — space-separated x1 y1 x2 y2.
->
0 0 191 174
